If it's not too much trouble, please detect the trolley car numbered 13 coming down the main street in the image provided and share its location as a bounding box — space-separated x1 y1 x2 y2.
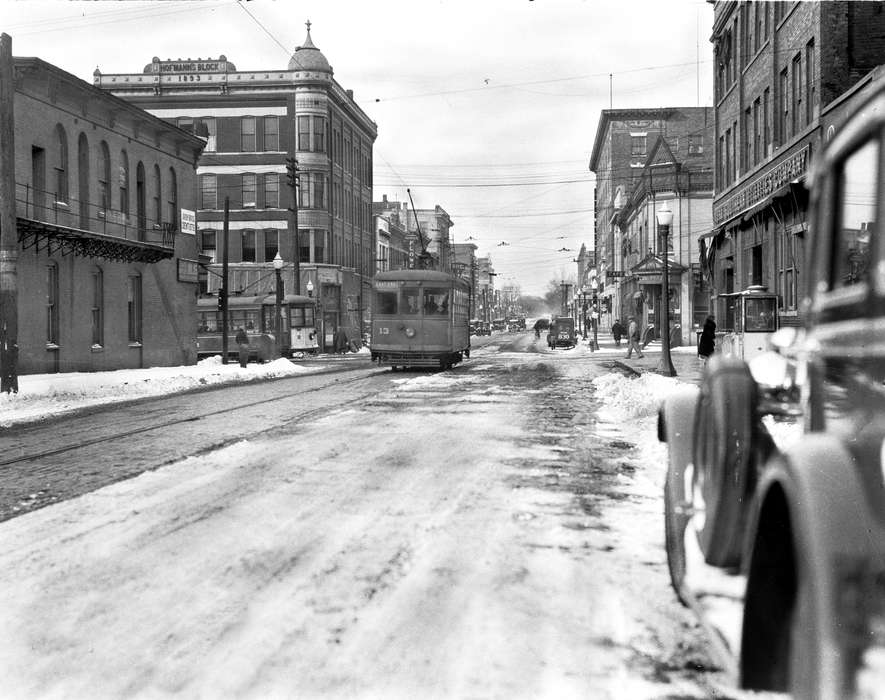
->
370 270 470 370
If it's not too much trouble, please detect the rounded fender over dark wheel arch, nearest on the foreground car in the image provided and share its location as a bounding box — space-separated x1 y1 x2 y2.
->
740 433 885 698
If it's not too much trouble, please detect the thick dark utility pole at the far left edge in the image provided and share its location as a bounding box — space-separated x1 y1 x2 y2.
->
0 34 18 394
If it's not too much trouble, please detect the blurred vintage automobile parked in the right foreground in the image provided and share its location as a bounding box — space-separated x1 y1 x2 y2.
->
658 88 885 698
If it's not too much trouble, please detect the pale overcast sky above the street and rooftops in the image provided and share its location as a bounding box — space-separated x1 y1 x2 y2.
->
0 0 713 294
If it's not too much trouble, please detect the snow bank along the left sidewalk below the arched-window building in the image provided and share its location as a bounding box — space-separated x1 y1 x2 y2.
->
0 355 316 427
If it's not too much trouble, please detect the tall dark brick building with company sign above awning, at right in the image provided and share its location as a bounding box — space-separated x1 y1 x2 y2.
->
702 1 885 330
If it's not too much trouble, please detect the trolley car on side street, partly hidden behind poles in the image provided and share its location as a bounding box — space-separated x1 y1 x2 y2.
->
197 294 319 362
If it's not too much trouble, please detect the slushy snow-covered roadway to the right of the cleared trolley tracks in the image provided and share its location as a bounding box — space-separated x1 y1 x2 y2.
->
0 333 737 698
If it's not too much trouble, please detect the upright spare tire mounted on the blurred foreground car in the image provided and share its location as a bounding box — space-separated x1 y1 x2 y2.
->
691 356 757 567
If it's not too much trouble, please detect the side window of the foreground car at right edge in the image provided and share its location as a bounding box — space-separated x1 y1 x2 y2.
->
830 141 879 289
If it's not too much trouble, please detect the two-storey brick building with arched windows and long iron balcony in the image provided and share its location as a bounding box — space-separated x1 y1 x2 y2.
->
3 58 203 374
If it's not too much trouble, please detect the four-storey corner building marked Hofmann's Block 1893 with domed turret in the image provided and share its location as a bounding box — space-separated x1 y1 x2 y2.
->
94 23 377 345
